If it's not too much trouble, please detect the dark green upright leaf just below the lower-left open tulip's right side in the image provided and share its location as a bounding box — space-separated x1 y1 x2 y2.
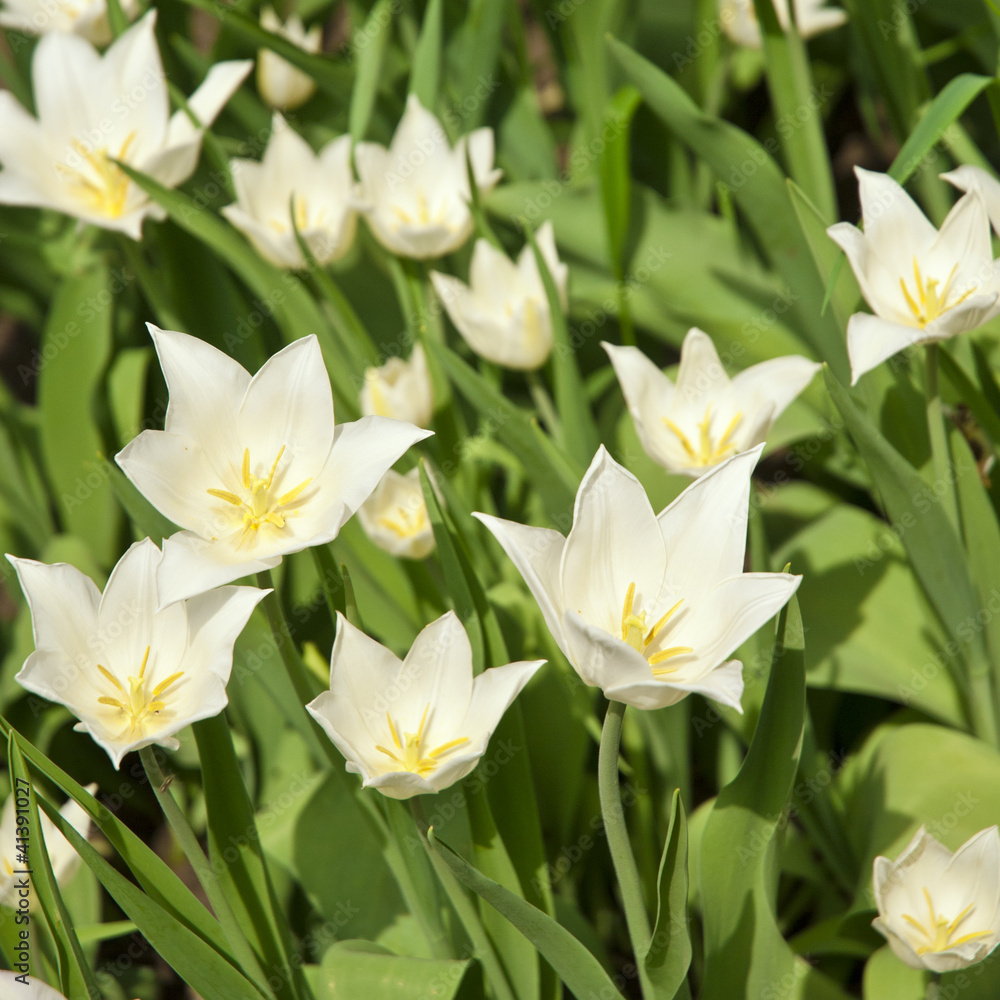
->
193 713 302 996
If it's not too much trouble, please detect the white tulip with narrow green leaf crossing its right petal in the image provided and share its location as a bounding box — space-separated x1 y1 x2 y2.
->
431 222 568 371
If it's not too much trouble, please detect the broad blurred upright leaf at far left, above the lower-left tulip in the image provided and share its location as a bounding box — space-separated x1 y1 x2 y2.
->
38 267 121 565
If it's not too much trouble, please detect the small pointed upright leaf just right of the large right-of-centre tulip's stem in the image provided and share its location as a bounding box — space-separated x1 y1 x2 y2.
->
640 791 691 1000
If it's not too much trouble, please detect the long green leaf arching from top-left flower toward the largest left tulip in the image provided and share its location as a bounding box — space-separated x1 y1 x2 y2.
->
119 163 360 417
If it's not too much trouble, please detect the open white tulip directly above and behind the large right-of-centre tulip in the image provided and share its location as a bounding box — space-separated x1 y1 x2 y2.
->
603 328 822 477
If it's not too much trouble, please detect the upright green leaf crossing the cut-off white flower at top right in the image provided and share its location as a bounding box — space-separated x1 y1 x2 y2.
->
753 0 837 225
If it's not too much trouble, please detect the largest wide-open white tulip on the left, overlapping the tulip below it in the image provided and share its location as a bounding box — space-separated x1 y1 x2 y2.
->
115 324 430 604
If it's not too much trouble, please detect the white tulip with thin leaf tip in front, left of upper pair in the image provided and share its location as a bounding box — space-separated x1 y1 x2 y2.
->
222 113 358 268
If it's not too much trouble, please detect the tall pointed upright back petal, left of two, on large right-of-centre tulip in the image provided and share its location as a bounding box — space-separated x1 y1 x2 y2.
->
560 445 666 632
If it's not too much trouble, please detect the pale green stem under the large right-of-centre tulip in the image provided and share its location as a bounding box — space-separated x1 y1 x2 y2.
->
597 701 656 997
